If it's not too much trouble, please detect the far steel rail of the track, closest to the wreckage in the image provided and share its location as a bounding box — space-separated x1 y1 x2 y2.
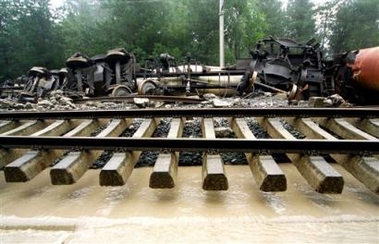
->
0 108 379 120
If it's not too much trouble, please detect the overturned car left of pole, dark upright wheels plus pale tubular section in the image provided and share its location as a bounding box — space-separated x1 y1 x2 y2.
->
63 48 243 97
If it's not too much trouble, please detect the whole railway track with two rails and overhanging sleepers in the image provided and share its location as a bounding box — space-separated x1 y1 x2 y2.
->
0 108 379 194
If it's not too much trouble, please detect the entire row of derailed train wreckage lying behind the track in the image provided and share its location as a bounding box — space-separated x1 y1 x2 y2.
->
2 37 379 104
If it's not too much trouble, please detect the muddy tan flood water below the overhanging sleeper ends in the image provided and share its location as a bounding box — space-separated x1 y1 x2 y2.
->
0 164 379 243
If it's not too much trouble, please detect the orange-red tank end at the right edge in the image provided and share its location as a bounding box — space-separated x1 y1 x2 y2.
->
351 46 379 91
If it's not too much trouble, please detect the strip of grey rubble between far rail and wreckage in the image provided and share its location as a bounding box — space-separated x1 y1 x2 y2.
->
0 90 302 111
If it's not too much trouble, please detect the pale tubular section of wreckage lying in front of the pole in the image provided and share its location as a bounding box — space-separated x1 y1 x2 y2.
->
137 53 245 95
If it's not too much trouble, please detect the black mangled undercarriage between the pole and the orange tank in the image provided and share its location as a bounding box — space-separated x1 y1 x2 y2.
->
237 37 324 99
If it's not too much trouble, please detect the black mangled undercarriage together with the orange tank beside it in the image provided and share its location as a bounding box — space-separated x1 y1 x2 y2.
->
237 37 379 104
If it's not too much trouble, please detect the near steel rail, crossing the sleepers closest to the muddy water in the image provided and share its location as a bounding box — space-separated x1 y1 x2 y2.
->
0 136 379 155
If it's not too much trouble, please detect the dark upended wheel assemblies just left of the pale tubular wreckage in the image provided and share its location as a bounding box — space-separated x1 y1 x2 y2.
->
65 48 135 96
